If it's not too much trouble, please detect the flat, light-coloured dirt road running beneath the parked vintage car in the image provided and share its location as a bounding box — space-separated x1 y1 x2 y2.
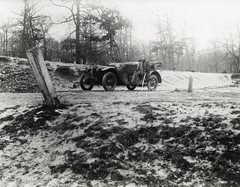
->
0 87 240 108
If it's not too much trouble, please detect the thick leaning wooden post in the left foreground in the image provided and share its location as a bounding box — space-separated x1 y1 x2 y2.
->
26 47 60 107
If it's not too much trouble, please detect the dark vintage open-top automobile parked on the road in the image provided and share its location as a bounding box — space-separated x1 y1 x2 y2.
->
80 60 162 91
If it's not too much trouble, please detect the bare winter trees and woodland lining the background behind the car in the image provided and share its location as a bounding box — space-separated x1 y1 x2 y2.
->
0 0 240 73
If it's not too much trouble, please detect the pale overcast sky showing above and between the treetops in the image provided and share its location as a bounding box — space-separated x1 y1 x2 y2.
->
0 0 240 49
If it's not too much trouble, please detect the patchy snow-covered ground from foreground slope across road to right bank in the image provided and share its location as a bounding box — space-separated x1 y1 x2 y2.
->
0 71 240 187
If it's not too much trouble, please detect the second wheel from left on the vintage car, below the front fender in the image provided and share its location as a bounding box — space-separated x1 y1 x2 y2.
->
102 72 117 91
